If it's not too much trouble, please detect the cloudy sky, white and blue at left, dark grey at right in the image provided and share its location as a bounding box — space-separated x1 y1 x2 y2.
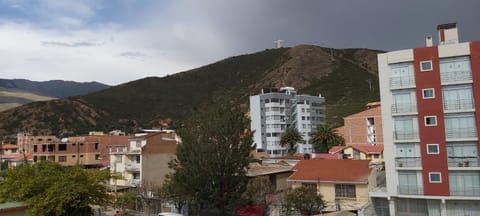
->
0 0 480 85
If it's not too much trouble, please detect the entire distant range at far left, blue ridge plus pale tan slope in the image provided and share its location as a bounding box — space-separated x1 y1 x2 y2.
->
0 79 109 112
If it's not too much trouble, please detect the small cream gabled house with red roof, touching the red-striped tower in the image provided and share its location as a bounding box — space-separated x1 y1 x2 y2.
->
328 144 383 160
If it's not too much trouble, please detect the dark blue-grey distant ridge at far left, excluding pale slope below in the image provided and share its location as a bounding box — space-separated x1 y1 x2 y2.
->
0 79 110 98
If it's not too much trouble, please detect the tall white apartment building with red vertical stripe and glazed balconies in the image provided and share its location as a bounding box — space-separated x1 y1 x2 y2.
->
371 23 480 216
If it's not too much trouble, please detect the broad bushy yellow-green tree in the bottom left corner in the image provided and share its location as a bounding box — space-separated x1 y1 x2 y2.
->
0 161 112 216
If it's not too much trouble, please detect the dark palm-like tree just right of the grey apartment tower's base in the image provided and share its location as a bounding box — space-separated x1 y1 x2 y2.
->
310 124 345 153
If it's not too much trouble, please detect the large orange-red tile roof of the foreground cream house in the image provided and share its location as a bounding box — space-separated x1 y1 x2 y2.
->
288 159 371 184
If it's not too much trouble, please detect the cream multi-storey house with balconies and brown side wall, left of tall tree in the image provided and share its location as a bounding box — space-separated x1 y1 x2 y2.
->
109 132 179 187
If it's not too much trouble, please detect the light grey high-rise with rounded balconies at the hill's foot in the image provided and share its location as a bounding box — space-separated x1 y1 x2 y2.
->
250 87 325 157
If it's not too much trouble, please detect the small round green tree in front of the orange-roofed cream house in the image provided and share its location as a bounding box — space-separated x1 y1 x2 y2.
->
285 187 325 215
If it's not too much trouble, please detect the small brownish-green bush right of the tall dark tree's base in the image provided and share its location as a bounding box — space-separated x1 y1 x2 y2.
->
243 176 275 209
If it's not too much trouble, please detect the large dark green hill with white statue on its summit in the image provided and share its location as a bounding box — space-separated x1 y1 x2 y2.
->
0 45 382 136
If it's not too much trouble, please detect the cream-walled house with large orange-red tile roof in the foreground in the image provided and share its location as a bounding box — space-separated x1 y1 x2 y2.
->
287 159 376 212
